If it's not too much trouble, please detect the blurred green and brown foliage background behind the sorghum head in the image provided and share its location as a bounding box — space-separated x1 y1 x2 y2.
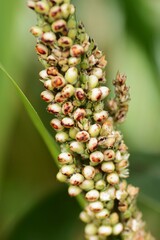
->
0 0 160 240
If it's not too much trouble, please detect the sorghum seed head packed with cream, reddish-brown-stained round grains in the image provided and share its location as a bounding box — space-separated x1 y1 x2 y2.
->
28 0 153 240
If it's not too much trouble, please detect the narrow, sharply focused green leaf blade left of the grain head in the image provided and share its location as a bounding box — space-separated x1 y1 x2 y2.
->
0 64 59 165
